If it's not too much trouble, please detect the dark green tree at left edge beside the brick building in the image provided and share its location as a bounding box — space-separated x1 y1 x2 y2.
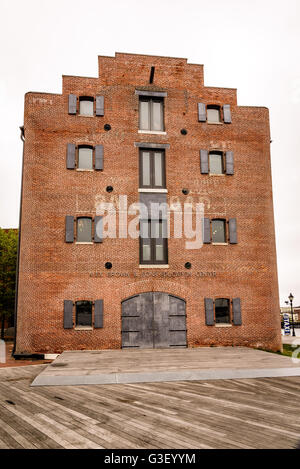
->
0 228 18 339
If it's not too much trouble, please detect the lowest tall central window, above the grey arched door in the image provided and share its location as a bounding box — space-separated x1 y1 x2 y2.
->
140 220 168 264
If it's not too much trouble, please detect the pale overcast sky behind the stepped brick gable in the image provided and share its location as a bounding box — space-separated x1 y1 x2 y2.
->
0 0 300 305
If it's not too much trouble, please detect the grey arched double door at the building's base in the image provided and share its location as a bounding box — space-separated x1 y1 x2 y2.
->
122 292 187 348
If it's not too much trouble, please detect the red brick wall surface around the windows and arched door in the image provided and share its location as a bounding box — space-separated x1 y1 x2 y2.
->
16 53 281 353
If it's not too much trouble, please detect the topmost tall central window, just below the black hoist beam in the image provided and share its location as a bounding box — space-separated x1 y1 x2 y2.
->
139 96 164 131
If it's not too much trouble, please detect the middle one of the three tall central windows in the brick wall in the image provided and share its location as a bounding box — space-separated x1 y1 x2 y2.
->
140 150 166 189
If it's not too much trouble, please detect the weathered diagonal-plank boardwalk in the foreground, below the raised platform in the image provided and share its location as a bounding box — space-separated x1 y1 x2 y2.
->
0 365 300 449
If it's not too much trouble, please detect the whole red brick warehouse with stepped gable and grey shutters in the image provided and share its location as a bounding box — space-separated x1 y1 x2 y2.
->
15 53 281 354
